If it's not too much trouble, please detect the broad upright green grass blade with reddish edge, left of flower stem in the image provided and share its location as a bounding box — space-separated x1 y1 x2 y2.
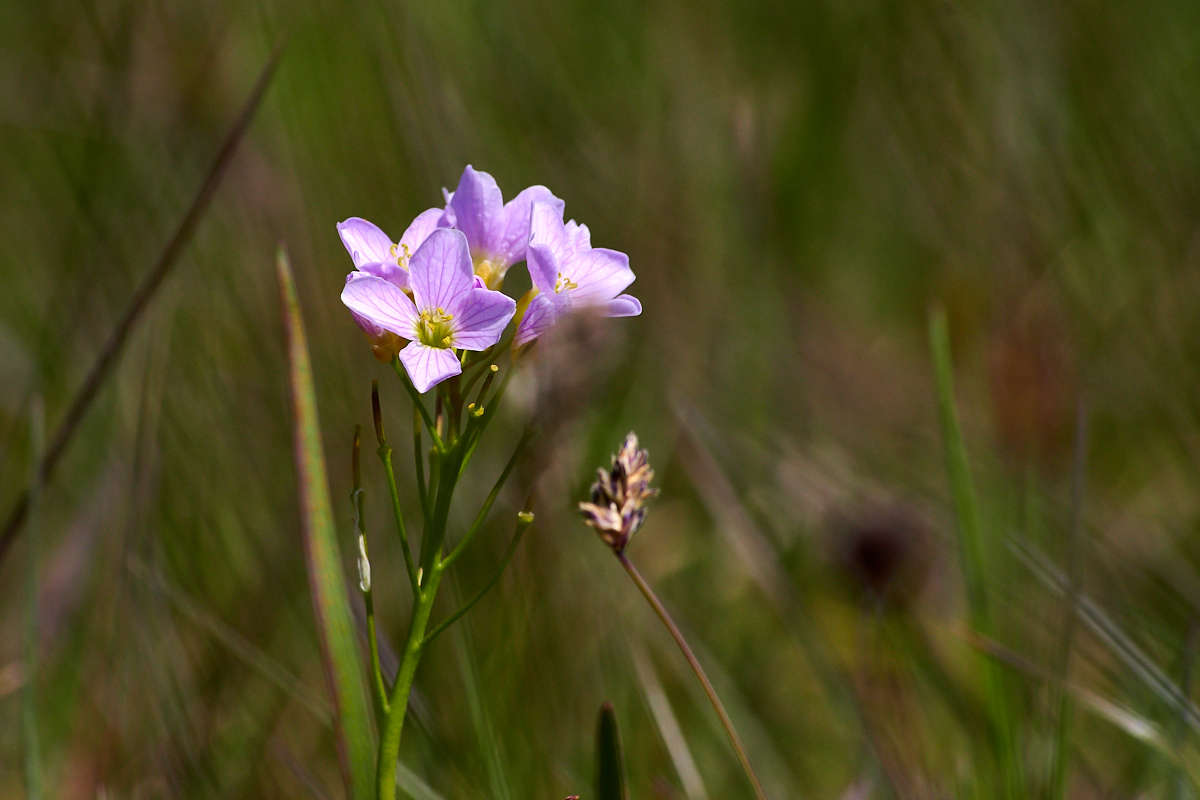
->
276 247 374 799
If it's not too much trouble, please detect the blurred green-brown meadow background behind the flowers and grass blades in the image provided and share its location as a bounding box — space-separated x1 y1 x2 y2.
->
0 0 1200 800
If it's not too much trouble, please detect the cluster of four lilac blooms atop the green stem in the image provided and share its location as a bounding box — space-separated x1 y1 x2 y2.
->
337 166 642 392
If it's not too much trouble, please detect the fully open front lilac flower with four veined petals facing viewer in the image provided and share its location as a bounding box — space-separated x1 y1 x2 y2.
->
342 228 515 392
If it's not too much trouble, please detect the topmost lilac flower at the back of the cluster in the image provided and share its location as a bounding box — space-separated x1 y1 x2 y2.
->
446 164 563 289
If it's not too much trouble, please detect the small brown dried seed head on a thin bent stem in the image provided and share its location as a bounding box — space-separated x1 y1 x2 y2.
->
580 433 659 553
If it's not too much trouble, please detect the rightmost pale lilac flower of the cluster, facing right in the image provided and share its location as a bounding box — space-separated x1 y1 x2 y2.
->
512 203 642 347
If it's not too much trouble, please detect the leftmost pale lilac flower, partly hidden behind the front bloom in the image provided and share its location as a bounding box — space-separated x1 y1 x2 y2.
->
337 209 446 363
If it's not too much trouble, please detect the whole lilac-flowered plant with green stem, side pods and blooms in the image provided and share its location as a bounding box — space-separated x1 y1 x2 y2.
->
337 166 653 800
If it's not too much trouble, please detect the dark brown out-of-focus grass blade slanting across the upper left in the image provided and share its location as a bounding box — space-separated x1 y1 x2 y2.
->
0 38 284 561
